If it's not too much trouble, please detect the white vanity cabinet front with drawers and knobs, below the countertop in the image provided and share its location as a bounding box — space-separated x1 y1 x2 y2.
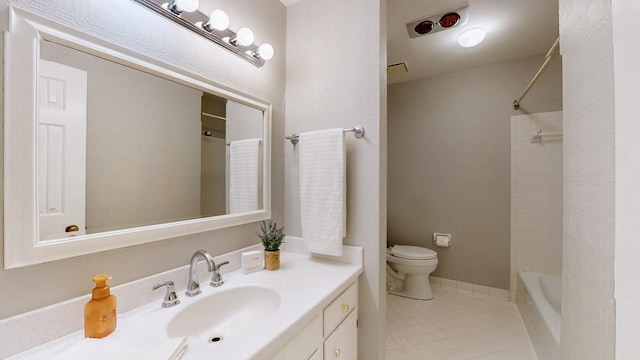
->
272 281 358 360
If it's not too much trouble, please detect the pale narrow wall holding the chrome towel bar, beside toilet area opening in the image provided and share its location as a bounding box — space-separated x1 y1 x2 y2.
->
284 0 386 359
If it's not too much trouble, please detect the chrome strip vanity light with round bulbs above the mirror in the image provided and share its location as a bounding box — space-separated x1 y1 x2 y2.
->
134 0 274 67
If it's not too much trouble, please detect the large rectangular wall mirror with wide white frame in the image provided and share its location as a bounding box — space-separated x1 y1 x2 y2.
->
4 9 271 269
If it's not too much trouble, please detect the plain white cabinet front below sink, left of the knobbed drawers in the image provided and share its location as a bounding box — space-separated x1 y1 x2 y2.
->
271 315 323 360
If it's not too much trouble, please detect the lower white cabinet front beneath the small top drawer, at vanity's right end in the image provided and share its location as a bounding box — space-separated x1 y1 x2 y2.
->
324 309 358 360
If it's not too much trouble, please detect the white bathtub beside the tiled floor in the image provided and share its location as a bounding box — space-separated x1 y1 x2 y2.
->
516 271 562 360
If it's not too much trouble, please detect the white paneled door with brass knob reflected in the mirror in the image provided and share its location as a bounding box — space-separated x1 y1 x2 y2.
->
37 60 87 240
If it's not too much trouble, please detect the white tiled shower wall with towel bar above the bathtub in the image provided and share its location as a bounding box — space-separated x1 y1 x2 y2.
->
511 111 563 299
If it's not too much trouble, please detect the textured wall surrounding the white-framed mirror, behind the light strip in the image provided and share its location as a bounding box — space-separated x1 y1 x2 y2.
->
0 0 286 319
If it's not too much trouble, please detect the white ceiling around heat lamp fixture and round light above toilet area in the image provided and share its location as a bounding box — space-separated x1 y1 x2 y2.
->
280 0 558 84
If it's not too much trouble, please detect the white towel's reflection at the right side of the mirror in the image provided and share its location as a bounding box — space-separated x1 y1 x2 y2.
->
229 139 262 214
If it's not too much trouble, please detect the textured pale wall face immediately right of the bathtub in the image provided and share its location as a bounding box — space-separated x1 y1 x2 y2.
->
560 0 616 360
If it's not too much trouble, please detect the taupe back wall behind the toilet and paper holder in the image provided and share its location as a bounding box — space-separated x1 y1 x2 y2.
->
388 54 562 289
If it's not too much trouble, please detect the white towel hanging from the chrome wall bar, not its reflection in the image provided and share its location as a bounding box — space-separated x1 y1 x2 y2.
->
299 129 347 256
